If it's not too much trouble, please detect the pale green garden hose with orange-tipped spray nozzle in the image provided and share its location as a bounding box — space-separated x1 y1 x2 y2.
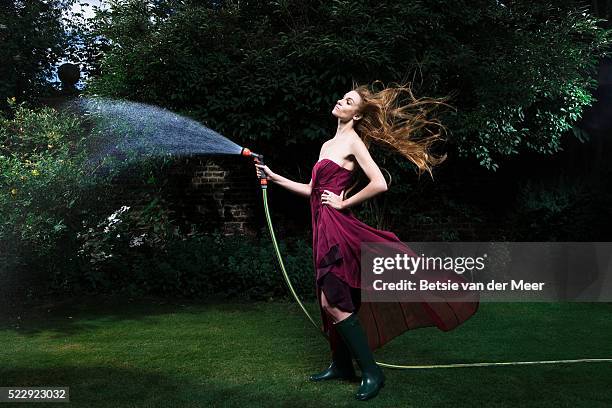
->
243 148 612 370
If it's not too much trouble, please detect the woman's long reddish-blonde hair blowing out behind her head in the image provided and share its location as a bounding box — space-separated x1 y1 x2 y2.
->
348 80 454 196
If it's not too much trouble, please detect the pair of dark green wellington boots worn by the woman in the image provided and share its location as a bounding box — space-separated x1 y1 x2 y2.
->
310 313 385 401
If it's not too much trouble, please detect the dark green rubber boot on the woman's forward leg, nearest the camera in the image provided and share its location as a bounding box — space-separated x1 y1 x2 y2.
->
336 313 385 401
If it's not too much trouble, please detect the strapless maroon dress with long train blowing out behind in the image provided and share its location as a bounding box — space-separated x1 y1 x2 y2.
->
310 159 479 350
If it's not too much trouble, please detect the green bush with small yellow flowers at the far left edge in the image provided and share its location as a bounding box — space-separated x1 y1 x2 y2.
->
0 97 101 256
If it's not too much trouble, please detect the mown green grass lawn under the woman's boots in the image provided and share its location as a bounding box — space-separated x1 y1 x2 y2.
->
0 298 612 407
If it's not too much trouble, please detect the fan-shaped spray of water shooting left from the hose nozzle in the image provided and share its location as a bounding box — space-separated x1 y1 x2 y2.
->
72 98 242 174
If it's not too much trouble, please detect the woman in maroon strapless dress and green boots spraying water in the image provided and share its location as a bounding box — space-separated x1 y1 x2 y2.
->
256 81 478 400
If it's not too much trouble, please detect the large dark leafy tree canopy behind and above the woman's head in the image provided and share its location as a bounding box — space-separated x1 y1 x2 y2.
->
81 0 612 170
